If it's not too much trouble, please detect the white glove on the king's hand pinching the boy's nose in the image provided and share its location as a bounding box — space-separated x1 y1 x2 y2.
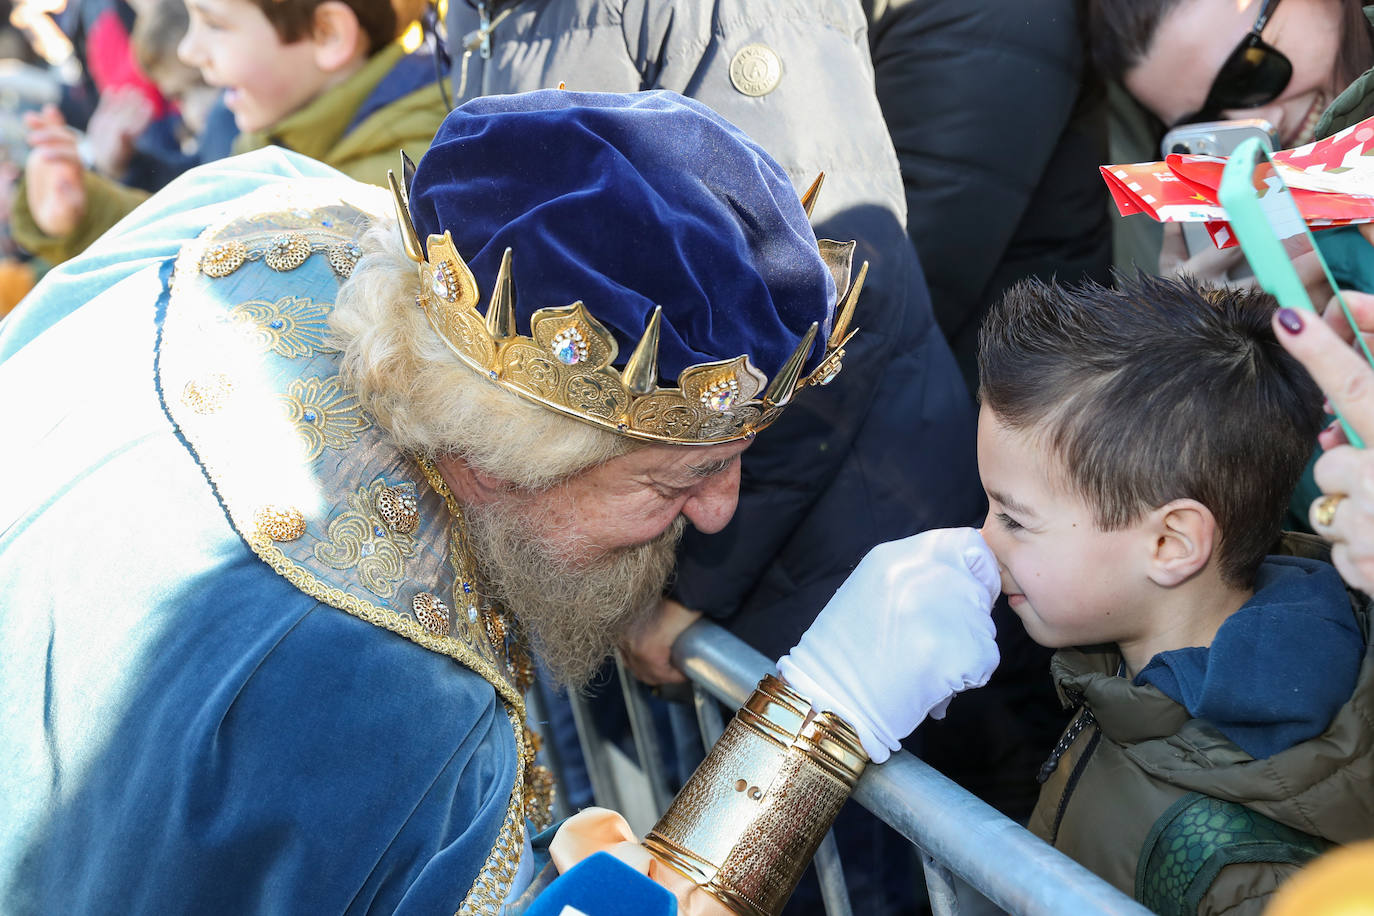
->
778 527 1002 764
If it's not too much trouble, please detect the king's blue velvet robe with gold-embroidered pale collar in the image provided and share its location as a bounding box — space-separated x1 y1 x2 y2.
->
0 150 528 915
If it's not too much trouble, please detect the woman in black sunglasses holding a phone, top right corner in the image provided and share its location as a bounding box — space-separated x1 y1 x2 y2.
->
1087 0 1374 289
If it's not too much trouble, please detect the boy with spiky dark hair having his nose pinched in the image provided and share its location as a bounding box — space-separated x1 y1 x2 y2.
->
978 275 1374 913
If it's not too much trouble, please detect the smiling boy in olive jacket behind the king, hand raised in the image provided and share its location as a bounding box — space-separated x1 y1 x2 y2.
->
14 0 448 262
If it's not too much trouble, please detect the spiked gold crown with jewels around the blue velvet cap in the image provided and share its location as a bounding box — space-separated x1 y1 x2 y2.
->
386 160 868 445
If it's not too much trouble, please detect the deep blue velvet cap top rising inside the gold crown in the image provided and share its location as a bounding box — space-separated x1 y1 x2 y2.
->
409 89 835 379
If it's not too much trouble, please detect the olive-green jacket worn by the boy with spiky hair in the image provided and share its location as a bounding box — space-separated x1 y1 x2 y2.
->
1029 536 1374 916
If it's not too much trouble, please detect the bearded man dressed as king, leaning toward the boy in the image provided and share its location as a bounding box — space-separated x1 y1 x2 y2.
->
0 91 996 913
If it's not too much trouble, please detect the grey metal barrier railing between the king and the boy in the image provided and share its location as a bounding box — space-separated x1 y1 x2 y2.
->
541 621 1150 916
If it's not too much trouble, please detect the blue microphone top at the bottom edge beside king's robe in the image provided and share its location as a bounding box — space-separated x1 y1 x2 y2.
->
525 853 677 916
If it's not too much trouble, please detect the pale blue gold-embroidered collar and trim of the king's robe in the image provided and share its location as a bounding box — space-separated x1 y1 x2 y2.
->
158 180 528 913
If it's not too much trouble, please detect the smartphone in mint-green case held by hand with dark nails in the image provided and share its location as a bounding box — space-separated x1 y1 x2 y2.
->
1217 137 1374 449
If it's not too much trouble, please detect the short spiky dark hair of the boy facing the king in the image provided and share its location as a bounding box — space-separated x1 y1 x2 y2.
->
978 273 1322 586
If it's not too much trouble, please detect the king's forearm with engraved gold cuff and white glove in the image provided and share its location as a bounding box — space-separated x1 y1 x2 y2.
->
568 529 1000 913
